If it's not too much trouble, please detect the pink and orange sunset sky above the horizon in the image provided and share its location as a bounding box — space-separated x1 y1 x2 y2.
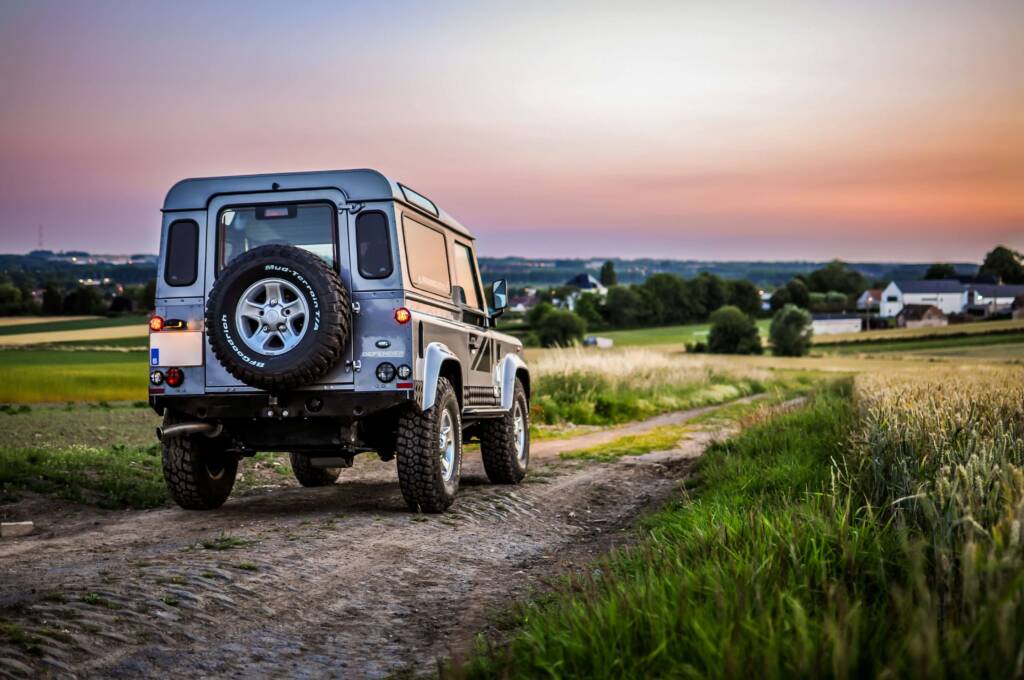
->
0 0 1024 261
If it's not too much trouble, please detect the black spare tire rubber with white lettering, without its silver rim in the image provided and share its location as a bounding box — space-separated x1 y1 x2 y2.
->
206 245 352 392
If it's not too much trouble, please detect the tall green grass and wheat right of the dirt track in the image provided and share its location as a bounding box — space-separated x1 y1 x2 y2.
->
460 367 1024 678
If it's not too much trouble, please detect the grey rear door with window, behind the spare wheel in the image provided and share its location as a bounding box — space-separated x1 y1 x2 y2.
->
204 189 354 391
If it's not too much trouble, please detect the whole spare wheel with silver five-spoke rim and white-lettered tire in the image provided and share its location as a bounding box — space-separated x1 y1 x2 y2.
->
206 245 352 391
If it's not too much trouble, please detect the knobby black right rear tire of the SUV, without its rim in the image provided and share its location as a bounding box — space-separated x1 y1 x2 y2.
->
395 378 462 512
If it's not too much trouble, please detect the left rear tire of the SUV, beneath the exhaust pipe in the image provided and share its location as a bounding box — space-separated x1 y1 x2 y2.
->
162 413 239 510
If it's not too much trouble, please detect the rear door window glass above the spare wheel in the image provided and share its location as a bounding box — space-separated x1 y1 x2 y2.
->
217 203 335 266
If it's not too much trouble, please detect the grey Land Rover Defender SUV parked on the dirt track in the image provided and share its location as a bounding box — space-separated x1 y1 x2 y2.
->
150 170 530 512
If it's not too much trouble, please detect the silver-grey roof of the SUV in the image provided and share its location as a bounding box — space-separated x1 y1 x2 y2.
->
164 170 473 239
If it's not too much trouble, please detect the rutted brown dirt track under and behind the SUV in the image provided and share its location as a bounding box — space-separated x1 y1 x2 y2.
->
0 401 761 678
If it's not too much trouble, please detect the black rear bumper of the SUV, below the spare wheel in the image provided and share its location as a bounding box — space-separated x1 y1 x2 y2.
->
150 389 416 421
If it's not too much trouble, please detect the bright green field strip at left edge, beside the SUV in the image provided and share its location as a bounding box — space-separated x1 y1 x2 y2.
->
0 349 150 403
